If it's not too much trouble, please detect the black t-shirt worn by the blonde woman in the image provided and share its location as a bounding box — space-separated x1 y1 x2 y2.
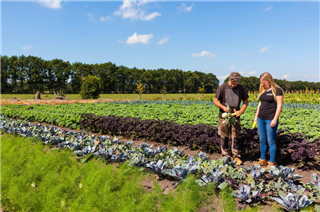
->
258 88 283 120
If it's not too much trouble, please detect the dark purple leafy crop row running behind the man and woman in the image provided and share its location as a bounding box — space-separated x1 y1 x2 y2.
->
80 113 320 170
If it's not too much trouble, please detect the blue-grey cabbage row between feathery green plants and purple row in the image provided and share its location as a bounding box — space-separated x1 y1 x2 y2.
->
0 117 320 211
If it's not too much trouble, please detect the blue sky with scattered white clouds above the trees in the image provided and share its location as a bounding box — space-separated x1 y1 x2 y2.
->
1 0 320 82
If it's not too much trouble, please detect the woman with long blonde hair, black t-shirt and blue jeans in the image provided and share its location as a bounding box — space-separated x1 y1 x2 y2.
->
254 72 283 170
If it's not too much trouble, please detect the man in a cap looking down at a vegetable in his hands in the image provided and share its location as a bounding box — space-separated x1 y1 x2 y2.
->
214 72 249 165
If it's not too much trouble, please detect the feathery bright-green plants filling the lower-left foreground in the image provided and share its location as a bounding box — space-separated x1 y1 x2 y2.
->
0 134 212 211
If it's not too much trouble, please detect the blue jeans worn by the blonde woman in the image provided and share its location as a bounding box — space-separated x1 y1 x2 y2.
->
258 118 279 163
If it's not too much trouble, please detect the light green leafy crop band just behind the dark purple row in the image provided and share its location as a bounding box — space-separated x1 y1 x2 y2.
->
0 103 320 141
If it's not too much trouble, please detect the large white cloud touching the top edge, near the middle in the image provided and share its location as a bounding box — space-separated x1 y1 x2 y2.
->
113 0 161 21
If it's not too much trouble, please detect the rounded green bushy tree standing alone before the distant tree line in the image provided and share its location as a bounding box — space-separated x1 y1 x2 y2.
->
79 75 101 99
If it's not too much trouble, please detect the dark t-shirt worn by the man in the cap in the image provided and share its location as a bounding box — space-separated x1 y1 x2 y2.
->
215 82 249 119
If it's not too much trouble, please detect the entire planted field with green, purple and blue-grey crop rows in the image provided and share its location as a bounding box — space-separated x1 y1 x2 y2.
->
0 91 320 212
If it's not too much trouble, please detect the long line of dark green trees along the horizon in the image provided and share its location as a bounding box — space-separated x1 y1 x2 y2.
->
0 55 320 94
